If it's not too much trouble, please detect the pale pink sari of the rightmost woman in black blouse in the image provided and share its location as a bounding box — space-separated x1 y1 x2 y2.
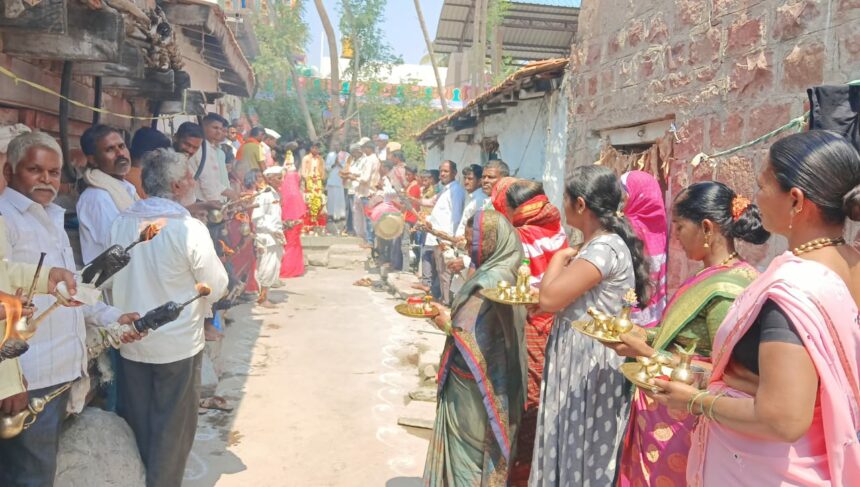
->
687 252 860 487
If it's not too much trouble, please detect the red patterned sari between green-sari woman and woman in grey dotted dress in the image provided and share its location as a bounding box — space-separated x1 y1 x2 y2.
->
492 177 568 486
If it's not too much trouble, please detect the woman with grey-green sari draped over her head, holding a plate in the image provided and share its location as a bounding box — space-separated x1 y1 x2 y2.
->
424 211 526 487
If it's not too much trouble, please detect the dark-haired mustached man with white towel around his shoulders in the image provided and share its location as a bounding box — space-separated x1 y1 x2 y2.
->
76 125 138 264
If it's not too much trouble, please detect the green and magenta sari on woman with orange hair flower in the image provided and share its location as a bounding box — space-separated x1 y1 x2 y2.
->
618 262 758 487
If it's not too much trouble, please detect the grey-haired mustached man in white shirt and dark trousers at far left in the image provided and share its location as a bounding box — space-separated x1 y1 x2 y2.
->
0 132 137 486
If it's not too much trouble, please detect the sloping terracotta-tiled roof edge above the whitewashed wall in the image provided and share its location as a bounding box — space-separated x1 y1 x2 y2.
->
415 57 569 140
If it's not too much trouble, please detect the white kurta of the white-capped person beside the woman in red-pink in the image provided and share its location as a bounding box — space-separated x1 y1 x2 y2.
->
251 191 285 287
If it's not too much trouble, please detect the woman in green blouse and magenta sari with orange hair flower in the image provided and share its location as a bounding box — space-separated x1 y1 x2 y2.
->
612 181 770 487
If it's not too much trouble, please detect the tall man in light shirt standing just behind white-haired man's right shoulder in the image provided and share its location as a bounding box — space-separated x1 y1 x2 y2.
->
188 113 236 201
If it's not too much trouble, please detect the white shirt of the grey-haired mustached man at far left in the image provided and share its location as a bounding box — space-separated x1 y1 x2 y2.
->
0 188 122 390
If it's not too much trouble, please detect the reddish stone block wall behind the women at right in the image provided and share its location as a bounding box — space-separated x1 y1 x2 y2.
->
567 0 860 285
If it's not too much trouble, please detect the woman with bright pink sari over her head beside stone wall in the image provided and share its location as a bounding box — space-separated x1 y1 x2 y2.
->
621 171 669 328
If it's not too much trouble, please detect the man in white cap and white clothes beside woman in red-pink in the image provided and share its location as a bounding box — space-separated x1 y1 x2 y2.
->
251 166 286 308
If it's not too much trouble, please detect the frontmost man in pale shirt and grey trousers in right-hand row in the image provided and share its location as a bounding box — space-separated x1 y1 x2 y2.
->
424 161 466 305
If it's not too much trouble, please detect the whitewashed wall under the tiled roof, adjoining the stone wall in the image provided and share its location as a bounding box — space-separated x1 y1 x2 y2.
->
425 90 568 210
